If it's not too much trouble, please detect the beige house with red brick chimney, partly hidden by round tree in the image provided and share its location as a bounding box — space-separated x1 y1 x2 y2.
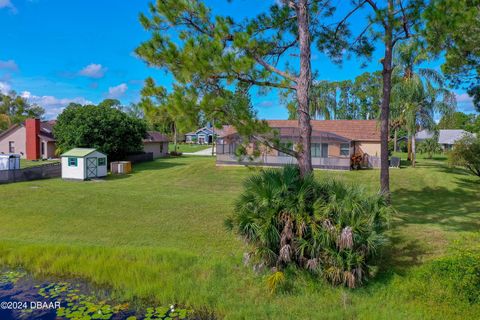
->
0 119 168 160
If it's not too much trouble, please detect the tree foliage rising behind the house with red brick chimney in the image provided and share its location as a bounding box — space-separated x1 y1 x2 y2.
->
0 91 45 132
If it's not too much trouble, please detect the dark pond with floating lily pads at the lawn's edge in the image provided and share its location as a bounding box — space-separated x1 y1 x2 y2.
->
0 270 204 320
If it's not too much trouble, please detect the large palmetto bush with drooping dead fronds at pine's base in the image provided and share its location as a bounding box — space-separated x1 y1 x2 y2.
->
226 166 392 288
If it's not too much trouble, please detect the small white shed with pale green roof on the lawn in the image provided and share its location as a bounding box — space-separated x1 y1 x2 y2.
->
62 148 107 180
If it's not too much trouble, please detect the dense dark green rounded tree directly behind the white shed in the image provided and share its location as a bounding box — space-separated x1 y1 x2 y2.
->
54 102 146 160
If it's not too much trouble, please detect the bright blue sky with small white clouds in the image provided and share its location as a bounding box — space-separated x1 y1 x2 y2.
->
0 0 473 119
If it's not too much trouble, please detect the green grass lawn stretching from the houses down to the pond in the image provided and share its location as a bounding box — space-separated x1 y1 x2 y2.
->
0 155 480 319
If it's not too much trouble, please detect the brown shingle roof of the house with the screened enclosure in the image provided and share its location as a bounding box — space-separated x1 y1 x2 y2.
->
221 120 380 141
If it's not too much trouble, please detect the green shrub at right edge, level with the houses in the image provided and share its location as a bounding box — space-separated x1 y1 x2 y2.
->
448 135 480 177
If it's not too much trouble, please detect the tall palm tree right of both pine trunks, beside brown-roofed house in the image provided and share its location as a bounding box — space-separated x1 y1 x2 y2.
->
392 41 456 167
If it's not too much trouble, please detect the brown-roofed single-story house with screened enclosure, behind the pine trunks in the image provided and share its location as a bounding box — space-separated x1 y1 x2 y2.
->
217 120 380 170
